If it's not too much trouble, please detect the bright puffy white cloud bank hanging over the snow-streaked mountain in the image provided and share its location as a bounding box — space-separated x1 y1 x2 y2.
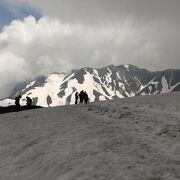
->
0 16 179 97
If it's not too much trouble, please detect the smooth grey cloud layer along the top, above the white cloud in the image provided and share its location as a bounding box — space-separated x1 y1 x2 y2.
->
23 0 180 24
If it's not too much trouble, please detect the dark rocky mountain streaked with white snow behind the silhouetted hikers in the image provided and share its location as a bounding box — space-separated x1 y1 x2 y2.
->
0 65 180 107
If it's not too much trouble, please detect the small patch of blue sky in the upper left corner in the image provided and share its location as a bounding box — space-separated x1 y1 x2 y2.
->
0 0 41 31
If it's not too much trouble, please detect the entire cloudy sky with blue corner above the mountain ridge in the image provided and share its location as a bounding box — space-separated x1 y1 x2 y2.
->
0 0 180 98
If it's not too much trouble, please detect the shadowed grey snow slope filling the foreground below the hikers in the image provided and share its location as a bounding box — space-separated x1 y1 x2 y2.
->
0 93 180 180
